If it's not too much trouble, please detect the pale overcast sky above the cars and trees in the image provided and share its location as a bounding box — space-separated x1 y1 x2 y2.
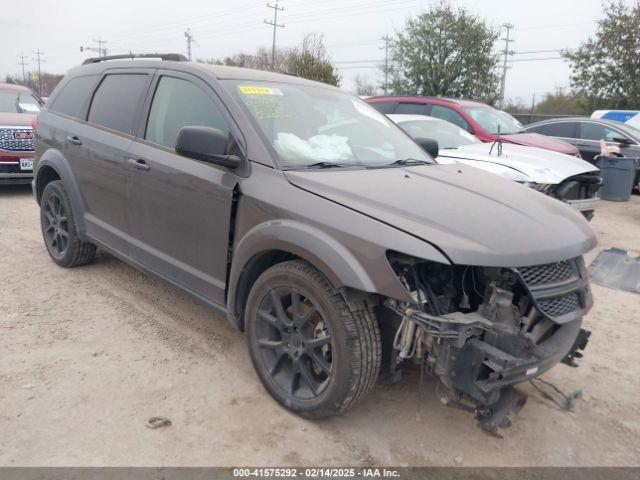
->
0 0 635 104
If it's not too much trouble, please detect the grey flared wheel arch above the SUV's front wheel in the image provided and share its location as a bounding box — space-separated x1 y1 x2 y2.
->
227 220 375 330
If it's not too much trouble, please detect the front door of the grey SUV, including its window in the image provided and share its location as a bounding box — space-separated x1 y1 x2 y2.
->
127 71 244 304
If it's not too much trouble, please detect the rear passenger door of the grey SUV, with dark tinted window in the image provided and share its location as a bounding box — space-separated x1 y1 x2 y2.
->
75 69 153 254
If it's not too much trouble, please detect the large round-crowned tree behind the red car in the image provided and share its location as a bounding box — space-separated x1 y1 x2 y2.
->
383 2 499 103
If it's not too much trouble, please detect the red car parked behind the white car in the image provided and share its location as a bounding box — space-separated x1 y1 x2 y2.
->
366 96 580 157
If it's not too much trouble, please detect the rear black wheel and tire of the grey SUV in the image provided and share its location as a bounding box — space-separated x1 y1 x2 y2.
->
40 180 96 268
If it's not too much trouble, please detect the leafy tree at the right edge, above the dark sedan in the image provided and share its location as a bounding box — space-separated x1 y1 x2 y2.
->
563 0 640 109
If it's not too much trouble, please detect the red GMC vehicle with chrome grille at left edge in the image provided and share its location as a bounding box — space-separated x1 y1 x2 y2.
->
0 83 43 185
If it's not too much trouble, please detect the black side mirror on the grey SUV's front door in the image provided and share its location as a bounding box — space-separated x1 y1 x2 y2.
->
176 127 242 170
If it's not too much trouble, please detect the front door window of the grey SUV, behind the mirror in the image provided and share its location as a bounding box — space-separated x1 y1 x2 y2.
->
145 77 229 148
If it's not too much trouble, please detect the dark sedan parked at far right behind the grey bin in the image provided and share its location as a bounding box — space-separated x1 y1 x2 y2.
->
525 117 640 188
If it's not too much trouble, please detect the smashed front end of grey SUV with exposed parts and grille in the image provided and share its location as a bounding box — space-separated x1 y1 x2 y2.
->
385 253 592 434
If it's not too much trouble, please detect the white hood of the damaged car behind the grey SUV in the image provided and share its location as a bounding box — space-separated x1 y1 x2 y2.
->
438 143 598 185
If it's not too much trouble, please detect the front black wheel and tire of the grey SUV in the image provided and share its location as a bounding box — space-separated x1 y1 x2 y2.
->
245 260 382 418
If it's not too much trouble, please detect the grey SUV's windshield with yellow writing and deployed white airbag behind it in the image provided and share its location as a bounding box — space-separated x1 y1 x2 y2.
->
229 81 435 168
